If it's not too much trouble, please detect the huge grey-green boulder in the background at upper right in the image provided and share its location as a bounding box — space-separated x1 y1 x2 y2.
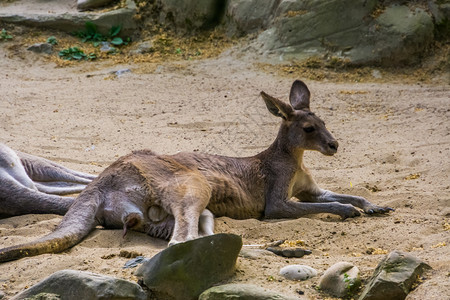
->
257 0 434 65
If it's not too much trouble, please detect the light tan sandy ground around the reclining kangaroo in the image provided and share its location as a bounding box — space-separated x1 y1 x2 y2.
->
0 36 450 299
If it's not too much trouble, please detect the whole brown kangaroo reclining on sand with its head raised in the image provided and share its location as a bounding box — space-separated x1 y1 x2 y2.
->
0 80 392 262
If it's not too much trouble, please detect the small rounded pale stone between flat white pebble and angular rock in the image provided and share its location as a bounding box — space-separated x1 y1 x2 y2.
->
319 262 361 298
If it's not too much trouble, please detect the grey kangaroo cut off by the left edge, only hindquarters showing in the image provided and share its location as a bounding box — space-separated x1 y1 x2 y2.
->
0 143 95 216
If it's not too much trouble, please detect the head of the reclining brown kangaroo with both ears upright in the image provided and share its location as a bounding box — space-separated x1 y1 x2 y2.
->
261 80 338 155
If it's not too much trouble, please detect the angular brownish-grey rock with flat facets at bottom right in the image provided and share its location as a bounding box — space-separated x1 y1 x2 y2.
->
359 251 431 300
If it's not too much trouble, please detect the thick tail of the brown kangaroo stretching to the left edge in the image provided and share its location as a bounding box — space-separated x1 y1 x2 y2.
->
0 190 101 262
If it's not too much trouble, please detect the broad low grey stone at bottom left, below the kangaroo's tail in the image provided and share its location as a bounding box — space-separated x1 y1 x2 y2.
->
13 270 147 300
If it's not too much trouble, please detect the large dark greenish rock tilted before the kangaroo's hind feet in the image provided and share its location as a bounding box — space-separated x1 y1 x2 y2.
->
135 234 242 300
